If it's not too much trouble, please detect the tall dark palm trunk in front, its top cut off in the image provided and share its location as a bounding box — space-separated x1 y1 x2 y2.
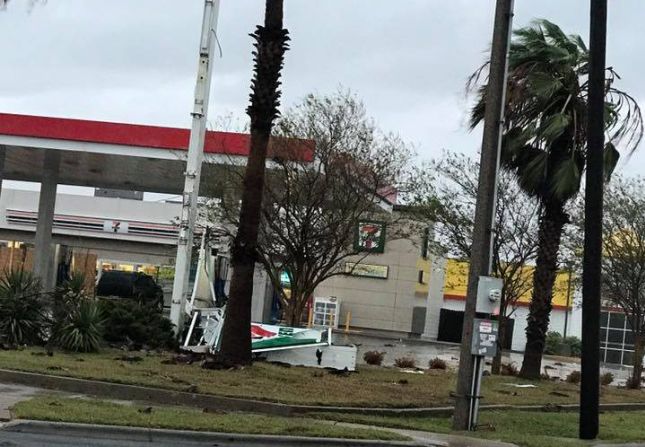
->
218 0 289 365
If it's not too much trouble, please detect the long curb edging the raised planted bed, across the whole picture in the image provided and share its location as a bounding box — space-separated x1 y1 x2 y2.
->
0 369 645 417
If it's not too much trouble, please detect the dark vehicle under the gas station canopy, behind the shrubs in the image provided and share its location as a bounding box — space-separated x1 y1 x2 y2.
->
96 270 163 310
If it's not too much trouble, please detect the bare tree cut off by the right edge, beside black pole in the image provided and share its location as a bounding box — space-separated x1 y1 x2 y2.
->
602 177 645 388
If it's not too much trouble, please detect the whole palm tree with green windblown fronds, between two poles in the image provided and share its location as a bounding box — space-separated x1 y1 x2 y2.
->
469 20 643 378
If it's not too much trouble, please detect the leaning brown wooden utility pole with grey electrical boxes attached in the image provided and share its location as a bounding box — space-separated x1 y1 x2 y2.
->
453 0 513 430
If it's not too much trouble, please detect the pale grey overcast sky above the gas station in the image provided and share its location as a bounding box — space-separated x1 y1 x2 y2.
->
0 0 645 196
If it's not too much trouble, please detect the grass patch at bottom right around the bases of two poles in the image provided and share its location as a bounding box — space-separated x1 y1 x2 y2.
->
317 411 645 447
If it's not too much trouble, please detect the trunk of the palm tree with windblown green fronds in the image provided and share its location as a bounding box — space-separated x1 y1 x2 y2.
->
519 200 568 379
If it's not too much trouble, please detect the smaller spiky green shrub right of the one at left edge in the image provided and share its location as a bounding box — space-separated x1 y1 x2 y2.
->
55 299 103 352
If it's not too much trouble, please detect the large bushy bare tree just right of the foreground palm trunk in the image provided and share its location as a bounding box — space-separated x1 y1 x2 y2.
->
211 91 417 325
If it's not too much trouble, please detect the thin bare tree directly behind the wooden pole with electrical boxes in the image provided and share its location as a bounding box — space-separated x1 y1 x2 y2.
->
432 152 539 374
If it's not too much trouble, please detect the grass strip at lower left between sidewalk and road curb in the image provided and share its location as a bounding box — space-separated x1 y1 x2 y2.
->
12 396 409 441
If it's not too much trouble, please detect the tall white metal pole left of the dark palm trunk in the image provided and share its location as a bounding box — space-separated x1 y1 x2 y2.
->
170 0 219 332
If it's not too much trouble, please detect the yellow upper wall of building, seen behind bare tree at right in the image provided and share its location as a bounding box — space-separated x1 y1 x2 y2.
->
443 259 571 307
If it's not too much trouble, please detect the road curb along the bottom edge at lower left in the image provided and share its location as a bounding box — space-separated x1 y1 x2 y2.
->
2 420 427 447
